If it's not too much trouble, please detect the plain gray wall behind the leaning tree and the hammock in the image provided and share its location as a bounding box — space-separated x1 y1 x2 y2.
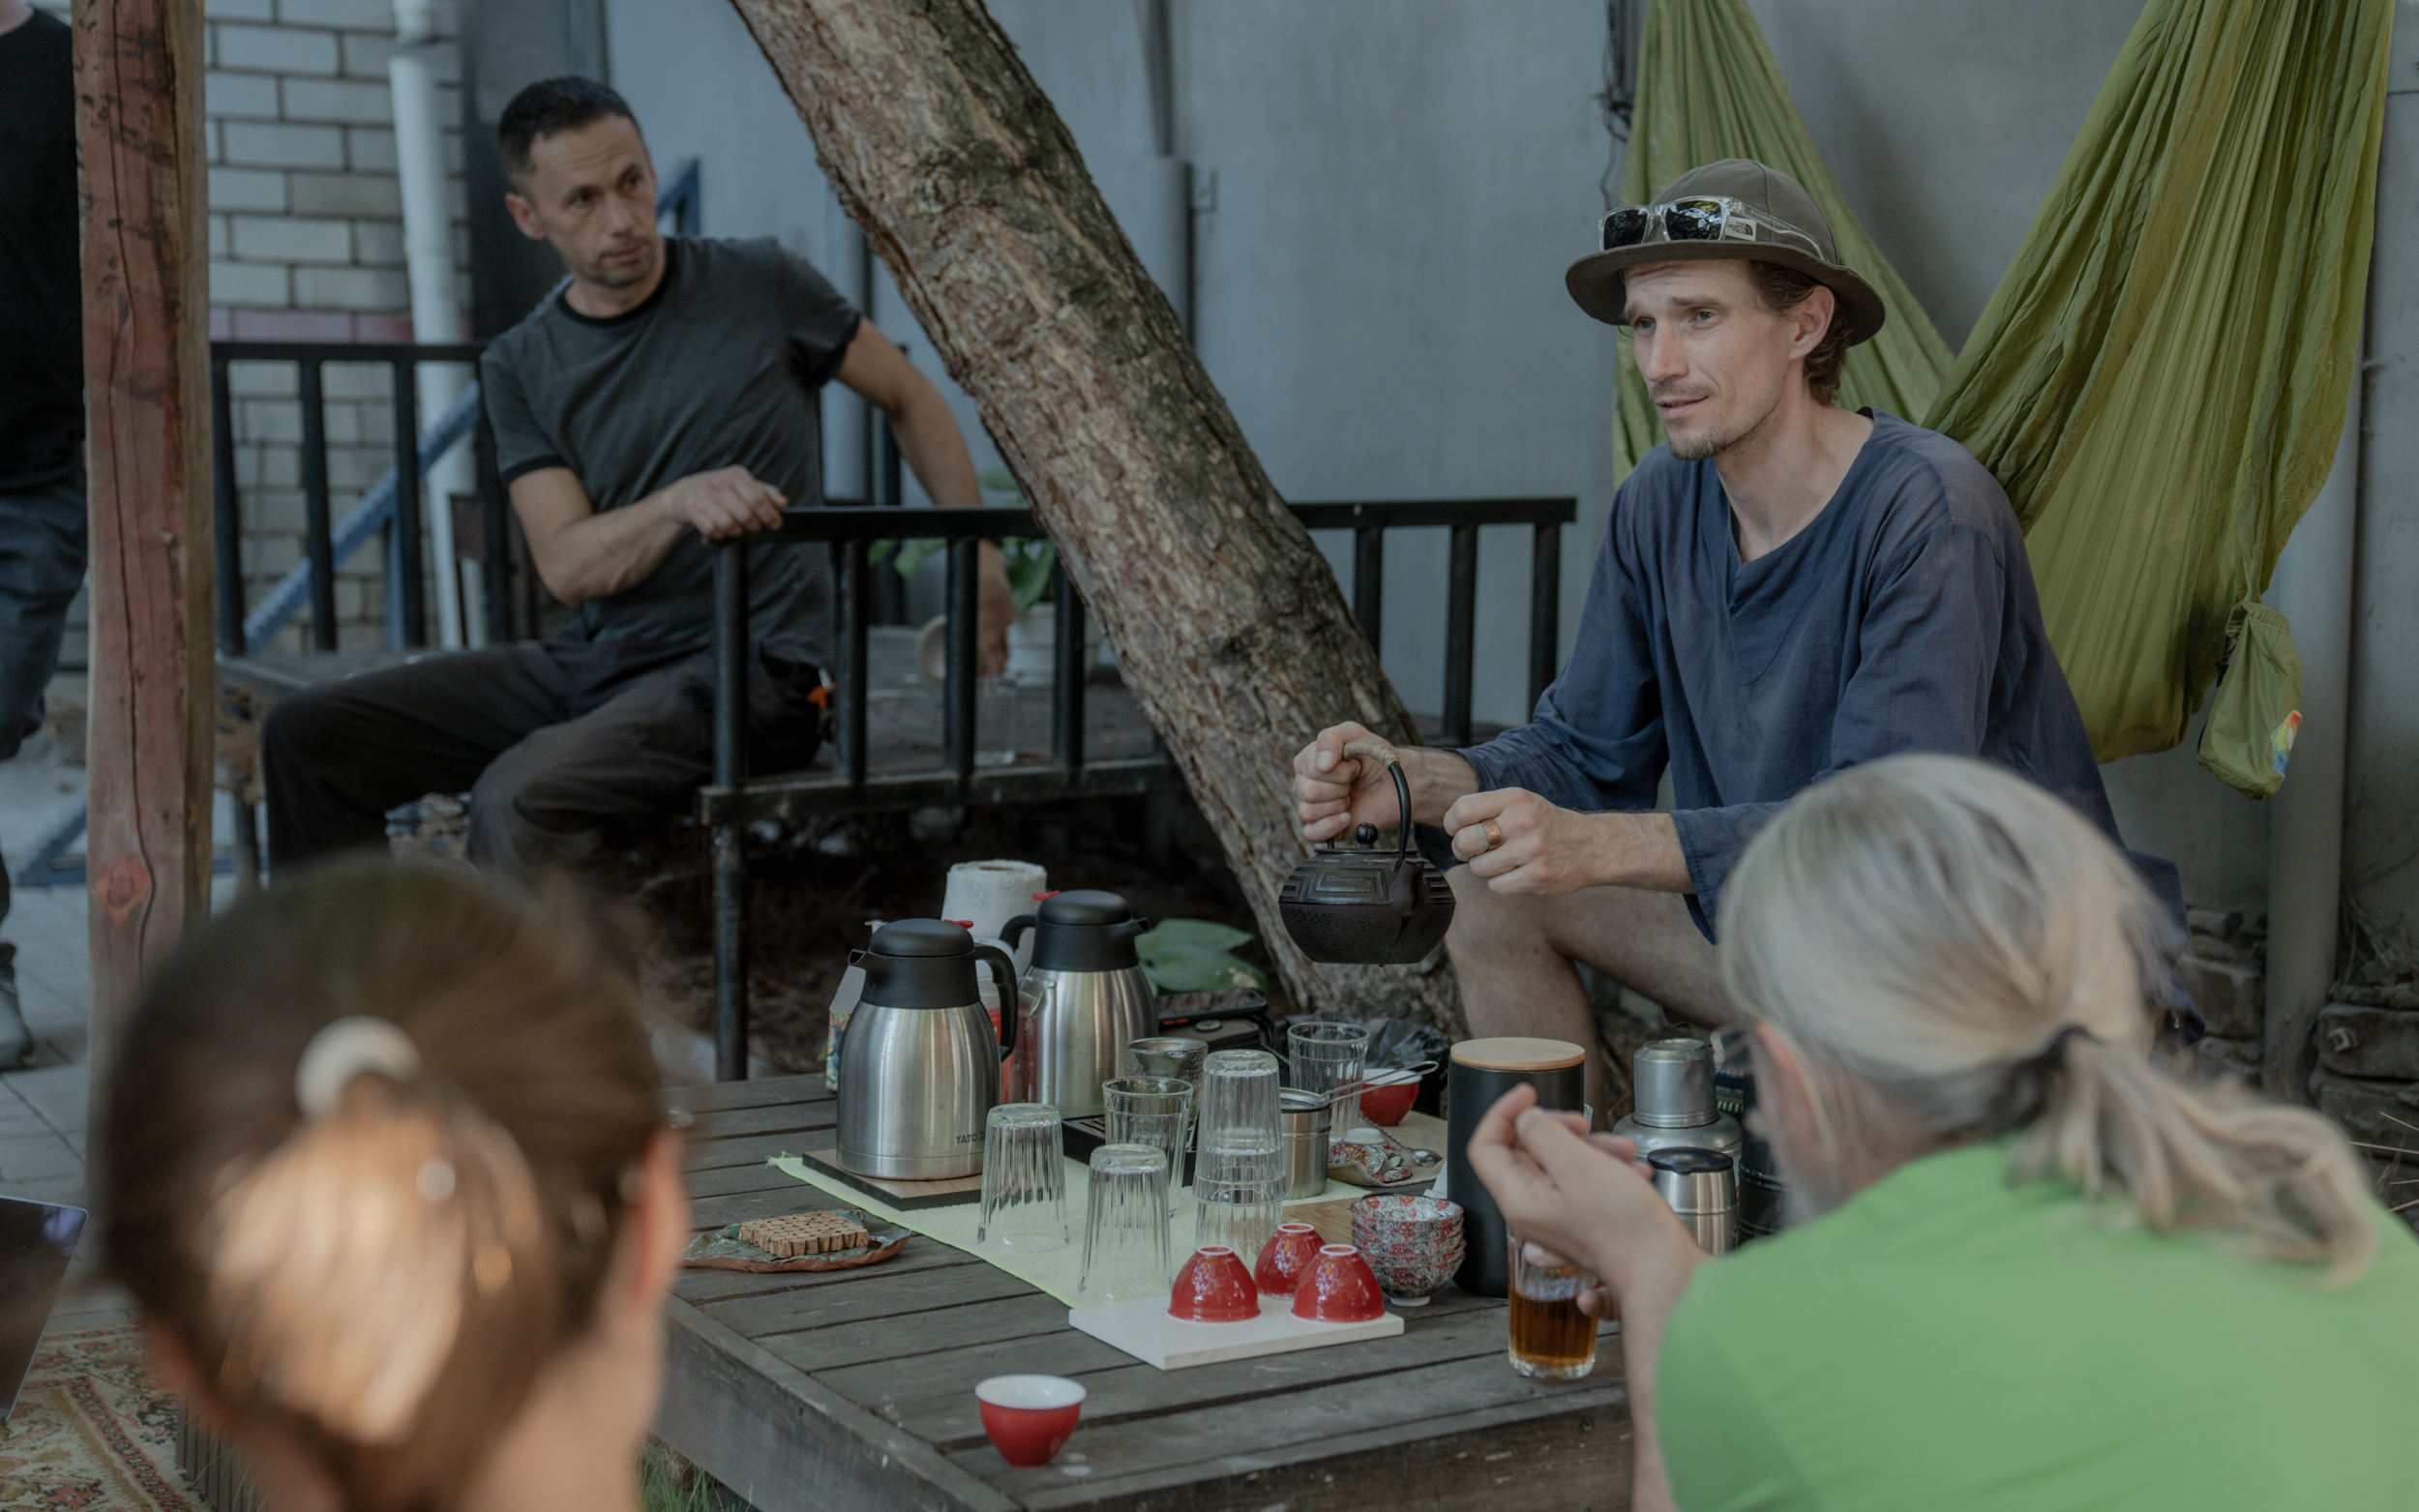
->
605 0 2419 909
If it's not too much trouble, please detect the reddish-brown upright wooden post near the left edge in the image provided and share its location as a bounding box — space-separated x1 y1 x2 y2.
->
75 0 216 1093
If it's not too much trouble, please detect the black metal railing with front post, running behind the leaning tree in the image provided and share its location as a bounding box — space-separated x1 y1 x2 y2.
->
700 498 1577 1082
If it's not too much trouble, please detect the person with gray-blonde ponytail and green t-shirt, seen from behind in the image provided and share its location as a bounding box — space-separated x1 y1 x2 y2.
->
1471 757 2419 1512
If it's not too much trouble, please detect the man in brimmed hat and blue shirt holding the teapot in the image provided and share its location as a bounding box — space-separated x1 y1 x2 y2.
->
1295 160 2196 1108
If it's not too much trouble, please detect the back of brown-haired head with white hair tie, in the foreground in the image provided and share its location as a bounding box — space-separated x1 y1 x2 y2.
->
97 866 690 1512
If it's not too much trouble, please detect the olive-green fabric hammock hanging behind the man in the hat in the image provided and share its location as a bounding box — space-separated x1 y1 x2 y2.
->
1614 0 2393 793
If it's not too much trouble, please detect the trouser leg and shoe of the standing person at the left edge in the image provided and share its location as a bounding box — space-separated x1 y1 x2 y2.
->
0 472 85 1067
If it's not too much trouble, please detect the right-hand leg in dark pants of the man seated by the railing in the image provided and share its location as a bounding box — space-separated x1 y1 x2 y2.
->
469 656 822 885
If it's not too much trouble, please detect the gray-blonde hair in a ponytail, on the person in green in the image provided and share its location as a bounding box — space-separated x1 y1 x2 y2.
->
1720 755 2375 1282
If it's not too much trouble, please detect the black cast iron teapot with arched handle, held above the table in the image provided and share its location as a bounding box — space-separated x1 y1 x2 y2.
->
1277 735 1454 965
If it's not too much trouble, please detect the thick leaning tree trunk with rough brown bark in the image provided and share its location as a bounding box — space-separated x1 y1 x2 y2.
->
733 0 1461 1028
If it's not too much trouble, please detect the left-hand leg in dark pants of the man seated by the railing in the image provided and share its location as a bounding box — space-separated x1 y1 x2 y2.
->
261 646 579 866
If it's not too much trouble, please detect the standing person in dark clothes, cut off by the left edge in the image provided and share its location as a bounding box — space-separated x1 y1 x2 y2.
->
0 0 85 1067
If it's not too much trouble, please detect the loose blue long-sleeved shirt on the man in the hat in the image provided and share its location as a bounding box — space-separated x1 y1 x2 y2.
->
1461 409 2192 938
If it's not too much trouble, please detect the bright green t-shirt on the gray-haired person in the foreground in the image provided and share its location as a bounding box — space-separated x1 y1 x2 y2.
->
1655 1144 2419 1512
